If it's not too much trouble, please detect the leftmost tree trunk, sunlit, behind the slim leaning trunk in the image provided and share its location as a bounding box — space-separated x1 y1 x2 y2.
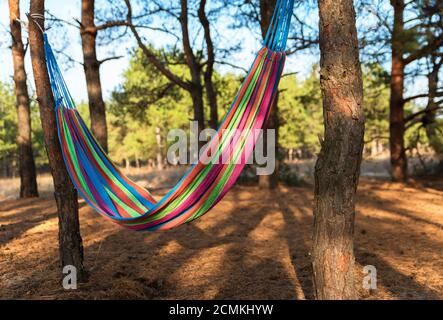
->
9 0 38 198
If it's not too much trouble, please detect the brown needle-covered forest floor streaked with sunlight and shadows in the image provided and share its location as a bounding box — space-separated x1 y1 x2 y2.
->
0 170 443 299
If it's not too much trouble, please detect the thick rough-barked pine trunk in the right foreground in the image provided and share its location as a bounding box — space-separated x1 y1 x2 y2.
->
312 0 364 299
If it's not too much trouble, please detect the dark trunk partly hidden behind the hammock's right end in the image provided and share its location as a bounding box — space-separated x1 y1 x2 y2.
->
258 0 279 189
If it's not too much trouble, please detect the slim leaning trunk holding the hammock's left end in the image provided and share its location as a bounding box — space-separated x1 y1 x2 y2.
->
29 0 87 281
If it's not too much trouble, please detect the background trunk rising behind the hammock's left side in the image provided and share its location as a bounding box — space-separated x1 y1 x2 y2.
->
80 0 108 152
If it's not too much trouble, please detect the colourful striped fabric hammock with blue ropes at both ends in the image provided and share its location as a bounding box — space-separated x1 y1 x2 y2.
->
44 0 294 231
